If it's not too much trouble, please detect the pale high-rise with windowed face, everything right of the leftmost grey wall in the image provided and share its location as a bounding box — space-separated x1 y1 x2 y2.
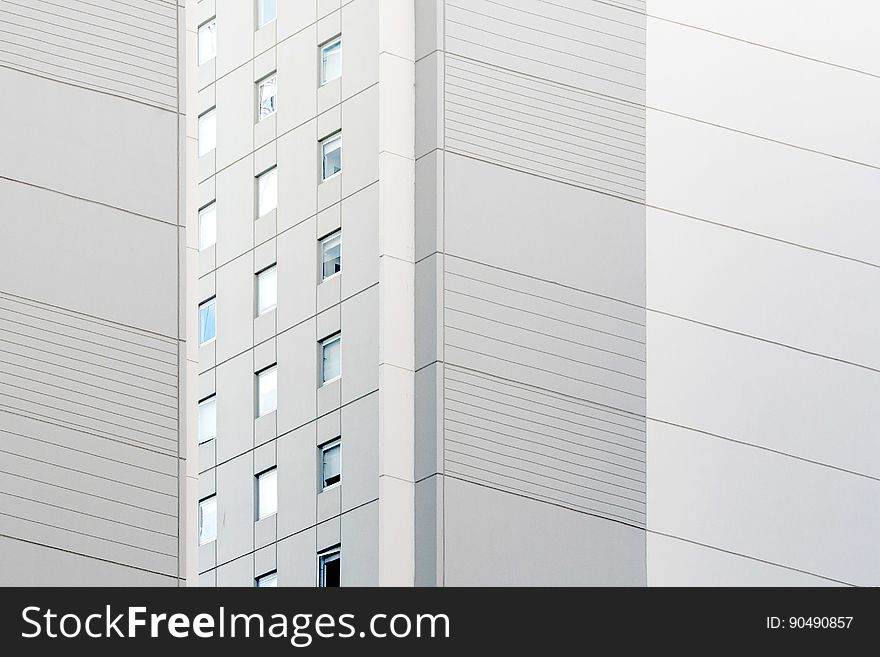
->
189 0 880 585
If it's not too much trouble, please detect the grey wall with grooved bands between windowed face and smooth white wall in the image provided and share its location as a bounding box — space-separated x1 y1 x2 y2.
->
416 0 646 585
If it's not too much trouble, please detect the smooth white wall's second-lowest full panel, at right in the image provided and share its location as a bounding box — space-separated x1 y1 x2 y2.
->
648 313 880 477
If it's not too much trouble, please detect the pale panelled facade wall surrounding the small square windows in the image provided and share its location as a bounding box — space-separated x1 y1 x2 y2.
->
188 0 414 586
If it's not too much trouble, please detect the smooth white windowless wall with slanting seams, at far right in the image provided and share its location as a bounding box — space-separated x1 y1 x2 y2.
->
646 0 880 585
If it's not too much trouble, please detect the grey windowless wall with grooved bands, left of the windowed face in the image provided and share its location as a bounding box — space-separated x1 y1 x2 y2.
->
0 0 189 586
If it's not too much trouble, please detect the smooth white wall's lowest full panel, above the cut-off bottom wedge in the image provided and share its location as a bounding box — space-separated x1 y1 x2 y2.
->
648 422 880 586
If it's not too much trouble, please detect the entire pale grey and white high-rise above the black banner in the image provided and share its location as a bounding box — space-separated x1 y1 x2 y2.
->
0 0 880 586
